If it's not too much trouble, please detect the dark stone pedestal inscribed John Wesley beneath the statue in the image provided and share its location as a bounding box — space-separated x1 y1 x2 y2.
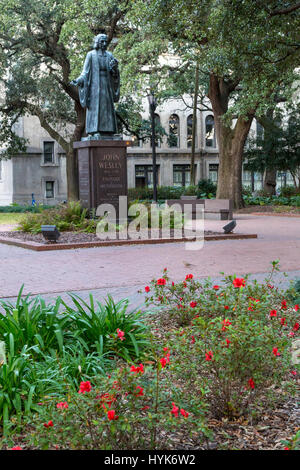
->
74 140 131 214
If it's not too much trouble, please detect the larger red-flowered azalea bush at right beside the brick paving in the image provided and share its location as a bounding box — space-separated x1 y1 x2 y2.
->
146 262 300 418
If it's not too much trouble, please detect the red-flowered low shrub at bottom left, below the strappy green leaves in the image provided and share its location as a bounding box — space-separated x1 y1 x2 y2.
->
4 357 211 450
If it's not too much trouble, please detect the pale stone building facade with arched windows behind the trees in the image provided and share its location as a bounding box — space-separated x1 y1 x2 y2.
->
0 94 292 205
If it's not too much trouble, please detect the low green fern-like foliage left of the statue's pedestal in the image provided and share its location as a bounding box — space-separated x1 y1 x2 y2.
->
18 201 97 233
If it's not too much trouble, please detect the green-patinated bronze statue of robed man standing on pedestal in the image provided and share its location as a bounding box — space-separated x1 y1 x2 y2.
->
71 34 120 140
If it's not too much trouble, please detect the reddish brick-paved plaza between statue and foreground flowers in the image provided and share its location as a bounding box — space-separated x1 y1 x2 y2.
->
0 214 300 306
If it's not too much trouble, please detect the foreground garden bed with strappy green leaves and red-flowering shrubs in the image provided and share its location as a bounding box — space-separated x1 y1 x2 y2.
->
0 261 300 451
